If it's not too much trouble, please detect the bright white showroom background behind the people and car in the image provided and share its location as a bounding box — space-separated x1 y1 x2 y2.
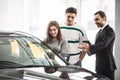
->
0 0 120 80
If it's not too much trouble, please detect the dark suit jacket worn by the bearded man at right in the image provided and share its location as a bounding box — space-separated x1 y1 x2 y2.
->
90 25 116 72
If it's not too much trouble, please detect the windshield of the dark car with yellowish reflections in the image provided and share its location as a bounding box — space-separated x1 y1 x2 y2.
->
0 34 66 68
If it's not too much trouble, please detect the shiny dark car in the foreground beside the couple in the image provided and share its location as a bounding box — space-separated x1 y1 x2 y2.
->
0 32 110 80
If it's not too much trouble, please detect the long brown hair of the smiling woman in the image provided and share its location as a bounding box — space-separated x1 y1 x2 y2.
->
45 21 62 43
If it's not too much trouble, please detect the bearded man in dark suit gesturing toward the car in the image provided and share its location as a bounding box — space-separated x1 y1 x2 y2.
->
79 11 116 80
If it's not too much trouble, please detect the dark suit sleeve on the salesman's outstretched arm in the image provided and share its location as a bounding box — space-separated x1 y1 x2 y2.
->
88 28 115 55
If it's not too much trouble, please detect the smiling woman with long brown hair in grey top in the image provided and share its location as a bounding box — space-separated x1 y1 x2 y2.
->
45 21 68 53
